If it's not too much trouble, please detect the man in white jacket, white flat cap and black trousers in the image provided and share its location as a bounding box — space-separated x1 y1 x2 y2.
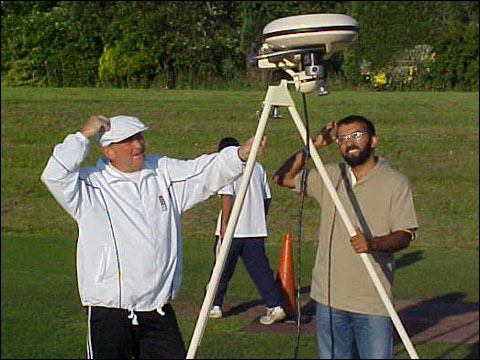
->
41 115 265 359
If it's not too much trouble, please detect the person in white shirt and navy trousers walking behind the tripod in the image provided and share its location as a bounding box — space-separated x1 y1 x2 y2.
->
208 137 286 325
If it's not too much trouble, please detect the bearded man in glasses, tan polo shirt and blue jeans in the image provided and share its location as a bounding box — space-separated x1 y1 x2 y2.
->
274 115 418 359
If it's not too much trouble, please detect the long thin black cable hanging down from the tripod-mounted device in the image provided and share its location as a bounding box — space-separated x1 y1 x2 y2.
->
293 93 310 359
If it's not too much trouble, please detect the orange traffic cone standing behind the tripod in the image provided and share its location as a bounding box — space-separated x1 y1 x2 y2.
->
277 231 297 316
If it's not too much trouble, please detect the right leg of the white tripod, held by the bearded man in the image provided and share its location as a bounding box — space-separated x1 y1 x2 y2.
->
288 106 419 359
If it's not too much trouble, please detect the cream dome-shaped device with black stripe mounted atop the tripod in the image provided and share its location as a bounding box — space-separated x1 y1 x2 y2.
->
248 14 359 95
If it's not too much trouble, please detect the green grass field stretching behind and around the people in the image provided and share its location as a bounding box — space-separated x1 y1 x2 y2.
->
1 88 479 359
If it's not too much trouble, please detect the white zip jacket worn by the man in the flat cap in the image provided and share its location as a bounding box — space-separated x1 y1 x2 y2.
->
41 132 243 313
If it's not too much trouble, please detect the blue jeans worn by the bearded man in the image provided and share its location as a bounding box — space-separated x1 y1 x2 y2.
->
316 302 393 359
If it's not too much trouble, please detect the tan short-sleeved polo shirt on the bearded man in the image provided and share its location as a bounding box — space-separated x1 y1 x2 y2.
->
295 157 418 316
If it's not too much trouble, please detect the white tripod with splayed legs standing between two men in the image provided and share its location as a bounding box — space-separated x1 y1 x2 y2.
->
187 80 419 359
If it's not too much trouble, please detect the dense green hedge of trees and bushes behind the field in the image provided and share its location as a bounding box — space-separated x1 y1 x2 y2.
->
1 1 479 91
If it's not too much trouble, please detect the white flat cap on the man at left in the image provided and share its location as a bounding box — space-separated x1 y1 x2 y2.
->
97 115 148 146
